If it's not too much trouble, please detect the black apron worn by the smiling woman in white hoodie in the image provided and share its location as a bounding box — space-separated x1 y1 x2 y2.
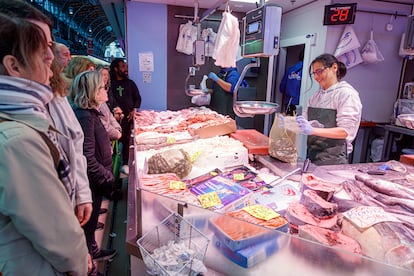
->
307 107 348 165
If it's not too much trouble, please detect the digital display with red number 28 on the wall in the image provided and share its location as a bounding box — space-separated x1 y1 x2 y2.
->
323 3 357 25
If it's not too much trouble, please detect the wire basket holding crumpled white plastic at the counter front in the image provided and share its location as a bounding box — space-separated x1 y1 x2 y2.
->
137 213 209 275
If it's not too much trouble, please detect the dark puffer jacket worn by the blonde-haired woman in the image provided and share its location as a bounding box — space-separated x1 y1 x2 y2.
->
74 108 115 194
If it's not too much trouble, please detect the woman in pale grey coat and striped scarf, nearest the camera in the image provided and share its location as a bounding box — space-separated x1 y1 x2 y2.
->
0 14 88 276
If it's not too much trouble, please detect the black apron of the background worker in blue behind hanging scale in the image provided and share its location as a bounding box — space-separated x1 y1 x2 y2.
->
211 72 236 119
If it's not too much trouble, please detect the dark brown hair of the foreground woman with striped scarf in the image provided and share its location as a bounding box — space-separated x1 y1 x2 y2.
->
0 13 48 75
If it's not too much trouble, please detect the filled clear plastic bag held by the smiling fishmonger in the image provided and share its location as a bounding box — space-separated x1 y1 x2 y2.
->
269 114 298 164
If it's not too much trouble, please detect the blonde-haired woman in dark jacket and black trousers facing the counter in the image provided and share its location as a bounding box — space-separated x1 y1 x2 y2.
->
69 71 116 261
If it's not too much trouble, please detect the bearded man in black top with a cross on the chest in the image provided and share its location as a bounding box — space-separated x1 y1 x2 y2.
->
108 58 141 174
